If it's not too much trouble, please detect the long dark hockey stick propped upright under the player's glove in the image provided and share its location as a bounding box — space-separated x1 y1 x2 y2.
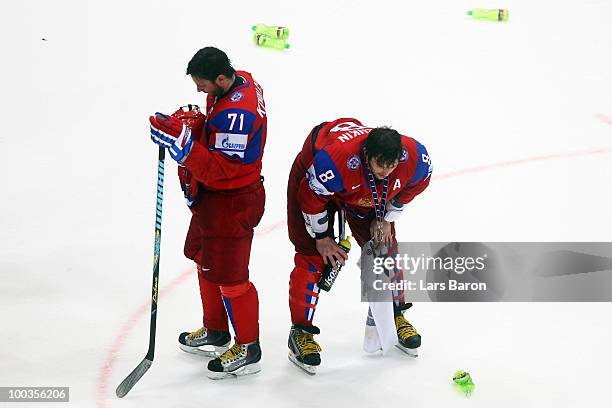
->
115 146 166 398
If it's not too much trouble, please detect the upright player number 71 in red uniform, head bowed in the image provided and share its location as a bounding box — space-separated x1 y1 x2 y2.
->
150 47 267 379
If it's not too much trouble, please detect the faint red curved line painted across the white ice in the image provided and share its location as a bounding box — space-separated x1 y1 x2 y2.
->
96 145 612 408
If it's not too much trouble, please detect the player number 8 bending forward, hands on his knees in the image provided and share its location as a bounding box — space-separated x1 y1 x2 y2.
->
287 118 431 373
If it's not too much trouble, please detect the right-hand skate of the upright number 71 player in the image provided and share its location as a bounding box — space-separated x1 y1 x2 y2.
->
208 340 261 380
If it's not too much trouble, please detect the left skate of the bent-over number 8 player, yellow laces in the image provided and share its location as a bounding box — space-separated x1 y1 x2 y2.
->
288 324 321 375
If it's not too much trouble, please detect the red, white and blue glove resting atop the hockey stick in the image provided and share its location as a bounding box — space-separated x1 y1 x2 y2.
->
149 112 193 165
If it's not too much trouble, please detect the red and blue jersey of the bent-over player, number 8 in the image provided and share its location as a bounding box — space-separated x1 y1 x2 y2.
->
298 118 432 234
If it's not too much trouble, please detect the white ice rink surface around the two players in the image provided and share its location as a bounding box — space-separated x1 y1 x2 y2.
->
0 0 612 408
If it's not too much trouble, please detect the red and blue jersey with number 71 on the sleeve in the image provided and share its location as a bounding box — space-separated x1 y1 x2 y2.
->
184 71 267 190
